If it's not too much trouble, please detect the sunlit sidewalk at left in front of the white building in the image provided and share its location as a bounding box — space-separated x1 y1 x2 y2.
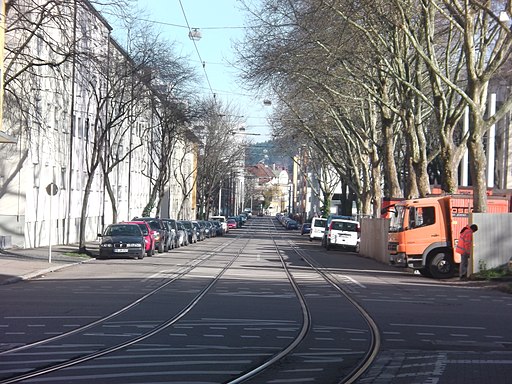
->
0 242 98 285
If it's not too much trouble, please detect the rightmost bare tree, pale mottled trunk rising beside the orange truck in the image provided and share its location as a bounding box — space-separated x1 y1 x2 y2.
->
403 0 512 212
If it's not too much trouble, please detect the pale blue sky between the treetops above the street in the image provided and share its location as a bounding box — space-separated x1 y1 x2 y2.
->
128 0 272 142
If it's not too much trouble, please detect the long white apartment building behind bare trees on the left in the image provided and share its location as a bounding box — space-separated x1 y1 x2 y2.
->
0 0 195 247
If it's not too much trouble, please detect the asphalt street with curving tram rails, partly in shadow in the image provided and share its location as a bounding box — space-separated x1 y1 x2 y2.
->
0 216 512 384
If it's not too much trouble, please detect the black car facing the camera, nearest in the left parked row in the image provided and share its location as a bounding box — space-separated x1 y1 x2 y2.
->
98 223 146 259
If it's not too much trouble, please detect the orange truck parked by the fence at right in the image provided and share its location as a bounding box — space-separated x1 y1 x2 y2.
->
387 195 510 279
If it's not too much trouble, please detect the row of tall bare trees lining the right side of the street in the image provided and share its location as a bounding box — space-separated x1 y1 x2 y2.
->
239 0 512 215
